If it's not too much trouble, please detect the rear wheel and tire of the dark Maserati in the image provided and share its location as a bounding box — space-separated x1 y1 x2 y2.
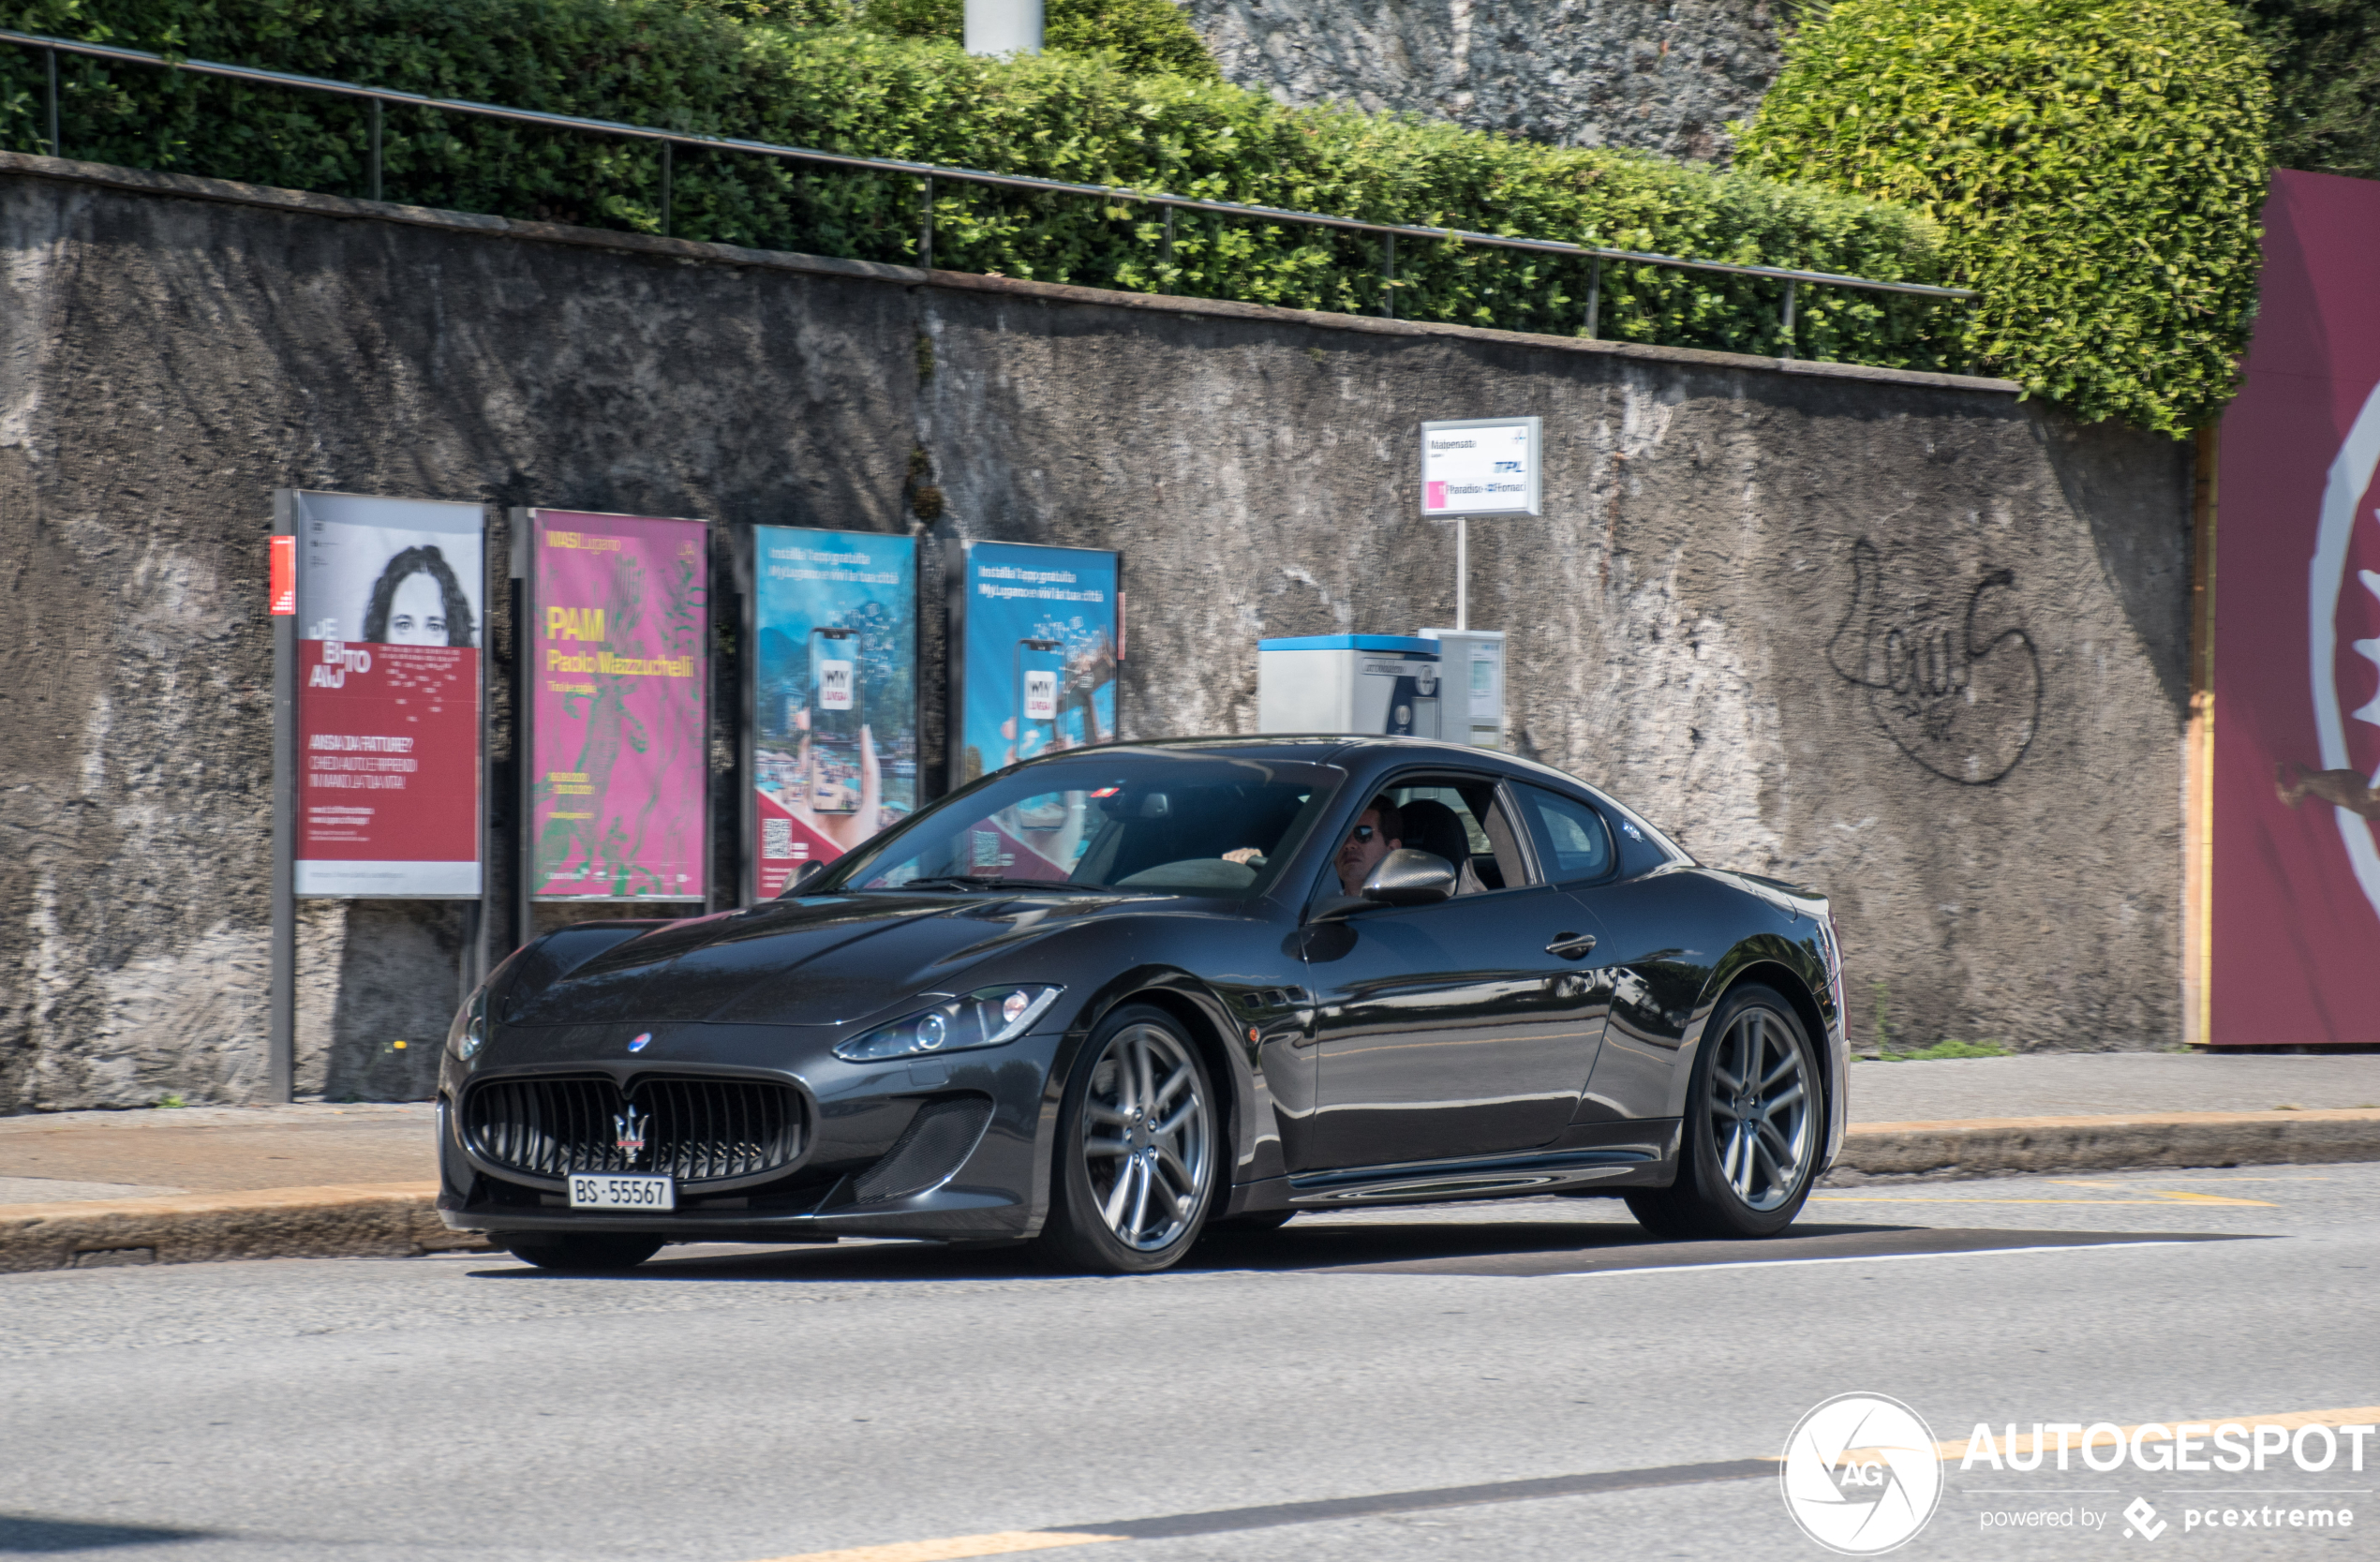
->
1628 986 1825 1241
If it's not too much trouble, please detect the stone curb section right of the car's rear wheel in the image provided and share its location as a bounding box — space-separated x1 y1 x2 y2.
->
1825 1109 2380 1185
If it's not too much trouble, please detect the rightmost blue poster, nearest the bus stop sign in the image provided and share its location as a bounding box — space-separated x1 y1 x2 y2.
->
949 543 1116 786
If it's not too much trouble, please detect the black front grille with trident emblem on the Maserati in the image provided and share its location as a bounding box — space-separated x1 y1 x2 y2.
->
462 1077 802 1183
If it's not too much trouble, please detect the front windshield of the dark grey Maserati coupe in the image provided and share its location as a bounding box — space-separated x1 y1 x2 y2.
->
799 748 1347 898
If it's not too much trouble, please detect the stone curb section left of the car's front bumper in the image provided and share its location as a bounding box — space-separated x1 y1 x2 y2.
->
0 1183 488 1274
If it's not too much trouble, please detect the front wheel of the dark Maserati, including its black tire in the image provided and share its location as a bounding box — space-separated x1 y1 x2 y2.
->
1037 1004 1224 1274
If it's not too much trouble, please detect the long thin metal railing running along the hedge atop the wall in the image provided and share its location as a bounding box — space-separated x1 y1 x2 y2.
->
0 28 1975 360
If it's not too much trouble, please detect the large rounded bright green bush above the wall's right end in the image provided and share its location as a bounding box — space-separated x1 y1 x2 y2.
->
1740 0 2270 433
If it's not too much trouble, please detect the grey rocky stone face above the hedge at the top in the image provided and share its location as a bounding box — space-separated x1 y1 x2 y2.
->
1178 0 1782 162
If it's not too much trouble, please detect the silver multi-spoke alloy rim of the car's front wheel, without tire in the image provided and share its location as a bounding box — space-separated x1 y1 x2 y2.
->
1083 1024 1213 1253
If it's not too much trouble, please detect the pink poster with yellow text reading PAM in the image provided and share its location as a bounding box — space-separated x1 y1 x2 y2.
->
521 510 709 900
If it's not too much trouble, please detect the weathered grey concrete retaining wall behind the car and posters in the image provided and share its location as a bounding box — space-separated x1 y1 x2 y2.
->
0 155 2190 1109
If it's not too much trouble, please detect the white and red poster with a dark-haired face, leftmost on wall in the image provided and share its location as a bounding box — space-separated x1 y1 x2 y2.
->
292 493 485 900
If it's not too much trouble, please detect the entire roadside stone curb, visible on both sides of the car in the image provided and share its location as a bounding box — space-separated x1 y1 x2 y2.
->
0 1109 2380 1274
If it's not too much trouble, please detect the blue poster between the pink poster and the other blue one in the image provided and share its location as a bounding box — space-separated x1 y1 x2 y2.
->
748 527 918 900
